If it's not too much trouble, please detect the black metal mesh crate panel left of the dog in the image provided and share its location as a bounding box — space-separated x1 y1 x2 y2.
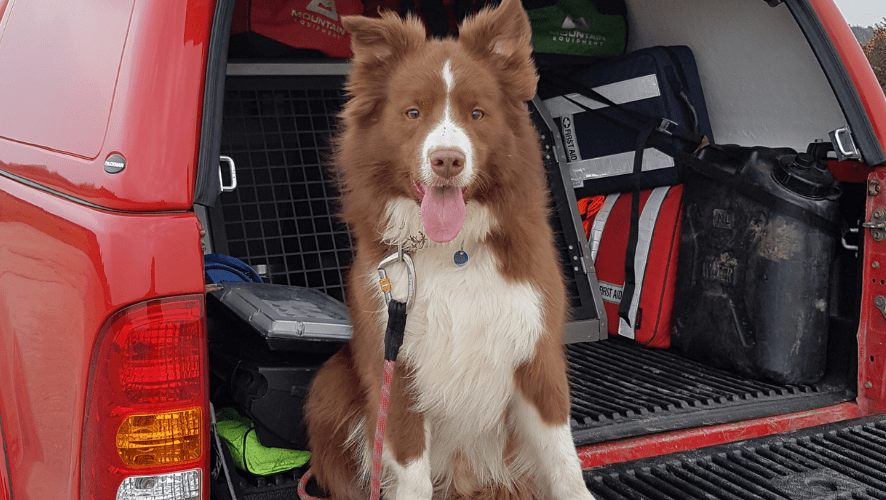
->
221 77 352 301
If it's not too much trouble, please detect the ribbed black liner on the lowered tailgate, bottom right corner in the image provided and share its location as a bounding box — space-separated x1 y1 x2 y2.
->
585 415 886 500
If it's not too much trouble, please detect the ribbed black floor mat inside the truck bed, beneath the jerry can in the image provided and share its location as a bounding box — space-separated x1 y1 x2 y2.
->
568 338 854 445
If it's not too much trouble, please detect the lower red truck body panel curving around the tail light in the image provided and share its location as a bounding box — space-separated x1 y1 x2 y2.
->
0 177 203 499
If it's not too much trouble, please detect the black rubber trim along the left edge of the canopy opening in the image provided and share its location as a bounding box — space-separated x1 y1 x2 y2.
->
194 0 236 207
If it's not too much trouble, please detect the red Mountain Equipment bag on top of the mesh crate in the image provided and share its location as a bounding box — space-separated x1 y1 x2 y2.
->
231 0 363 58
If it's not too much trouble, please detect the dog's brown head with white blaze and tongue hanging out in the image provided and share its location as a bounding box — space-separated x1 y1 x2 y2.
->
337 0 538 243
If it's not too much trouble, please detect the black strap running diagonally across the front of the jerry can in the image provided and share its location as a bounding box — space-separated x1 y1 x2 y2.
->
675 153 840 235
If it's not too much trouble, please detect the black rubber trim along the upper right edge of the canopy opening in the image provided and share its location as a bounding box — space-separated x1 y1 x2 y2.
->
784 0 886 167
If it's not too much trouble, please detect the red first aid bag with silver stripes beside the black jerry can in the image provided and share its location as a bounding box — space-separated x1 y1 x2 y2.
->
580 185 683 348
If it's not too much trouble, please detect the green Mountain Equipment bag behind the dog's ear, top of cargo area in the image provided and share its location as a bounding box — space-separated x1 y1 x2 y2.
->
523 0 628 57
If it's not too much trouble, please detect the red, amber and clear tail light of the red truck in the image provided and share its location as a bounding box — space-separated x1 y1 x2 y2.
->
80 295 209 500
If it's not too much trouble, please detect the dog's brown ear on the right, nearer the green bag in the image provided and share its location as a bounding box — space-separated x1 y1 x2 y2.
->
459 0 538 101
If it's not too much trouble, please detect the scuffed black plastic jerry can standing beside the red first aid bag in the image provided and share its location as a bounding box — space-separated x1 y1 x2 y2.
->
672 145 840 384
